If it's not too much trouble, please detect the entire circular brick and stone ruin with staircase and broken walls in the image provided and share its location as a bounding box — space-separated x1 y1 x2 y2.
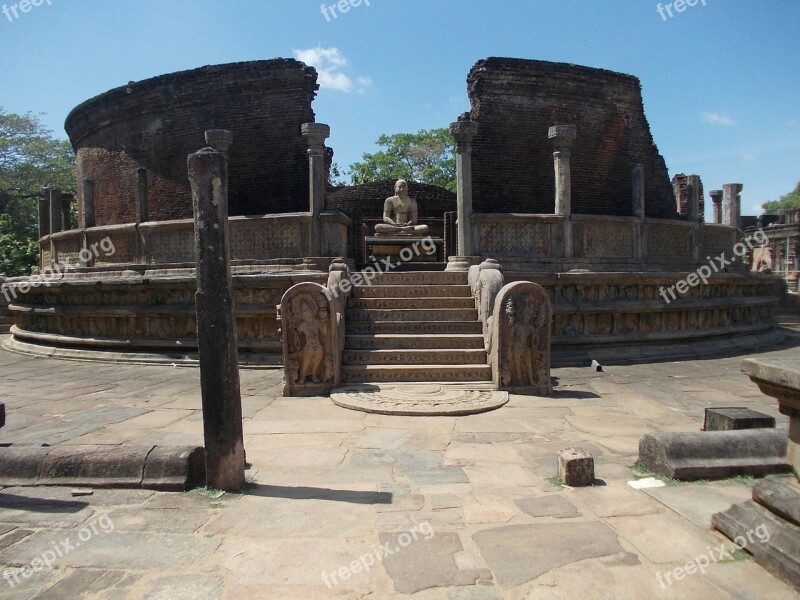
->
3 58 781 395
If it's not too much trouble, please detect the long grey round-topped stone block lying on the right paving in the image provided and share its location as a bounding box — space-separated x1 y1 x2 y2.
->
638 428 789 480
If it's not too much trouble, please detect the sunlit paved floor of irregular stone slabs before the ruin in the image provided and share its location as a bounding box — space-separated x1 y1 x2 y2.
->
0 336 800 600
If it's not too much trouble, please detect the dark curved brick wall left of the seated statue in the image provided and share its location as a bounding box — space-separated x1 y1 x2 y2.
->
65 59 318 226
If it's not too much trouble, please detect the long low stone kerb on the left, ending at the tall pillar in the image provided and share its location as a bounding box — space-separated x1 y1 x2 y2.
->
0 445 205 491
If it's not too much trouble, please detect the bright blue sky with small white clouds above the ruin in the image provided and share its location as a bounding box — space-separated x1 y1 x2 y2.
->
0 0 800 214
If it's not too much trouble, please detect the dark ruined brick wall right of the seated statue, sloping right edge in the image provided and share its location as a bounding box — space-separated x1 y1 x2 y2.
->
467 58 676 218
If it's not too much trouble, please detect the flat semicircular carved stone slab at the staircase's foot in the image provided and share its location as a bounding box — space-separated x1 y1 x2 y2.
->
331 383 508 417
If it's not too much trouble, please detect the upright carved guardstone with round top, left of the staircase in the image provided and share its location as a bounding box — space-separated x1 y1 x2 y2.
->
278 282 341 396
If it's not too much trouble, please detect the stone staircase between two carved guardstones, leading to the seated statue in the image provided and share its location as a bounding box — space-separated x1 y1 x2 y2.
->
342 271 492 384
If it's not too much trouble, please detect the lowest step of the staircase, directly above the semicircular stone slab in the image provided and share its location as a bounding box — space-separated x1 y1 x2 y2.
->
342 364 492 384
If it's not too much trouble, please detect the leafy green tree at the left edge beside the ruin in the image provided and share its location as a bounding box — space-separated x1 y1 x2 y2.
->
0 107 75 277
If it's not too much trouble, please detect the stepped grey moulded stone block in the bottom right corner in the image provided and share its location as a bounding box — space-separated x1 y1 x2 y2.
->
711 500 800 590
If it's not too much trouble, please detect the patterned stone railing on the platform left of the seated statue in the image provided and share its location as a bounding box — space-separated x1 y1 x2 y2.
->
39 211 350 267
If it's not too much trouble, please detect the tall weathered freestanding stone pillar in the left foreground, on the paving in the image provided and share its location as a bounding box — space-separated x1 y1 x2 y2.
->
187 131 245 491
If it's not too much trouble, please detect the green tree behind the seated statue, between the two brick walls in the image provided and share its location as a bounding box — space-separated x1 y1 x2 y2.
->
350 128 456 192
